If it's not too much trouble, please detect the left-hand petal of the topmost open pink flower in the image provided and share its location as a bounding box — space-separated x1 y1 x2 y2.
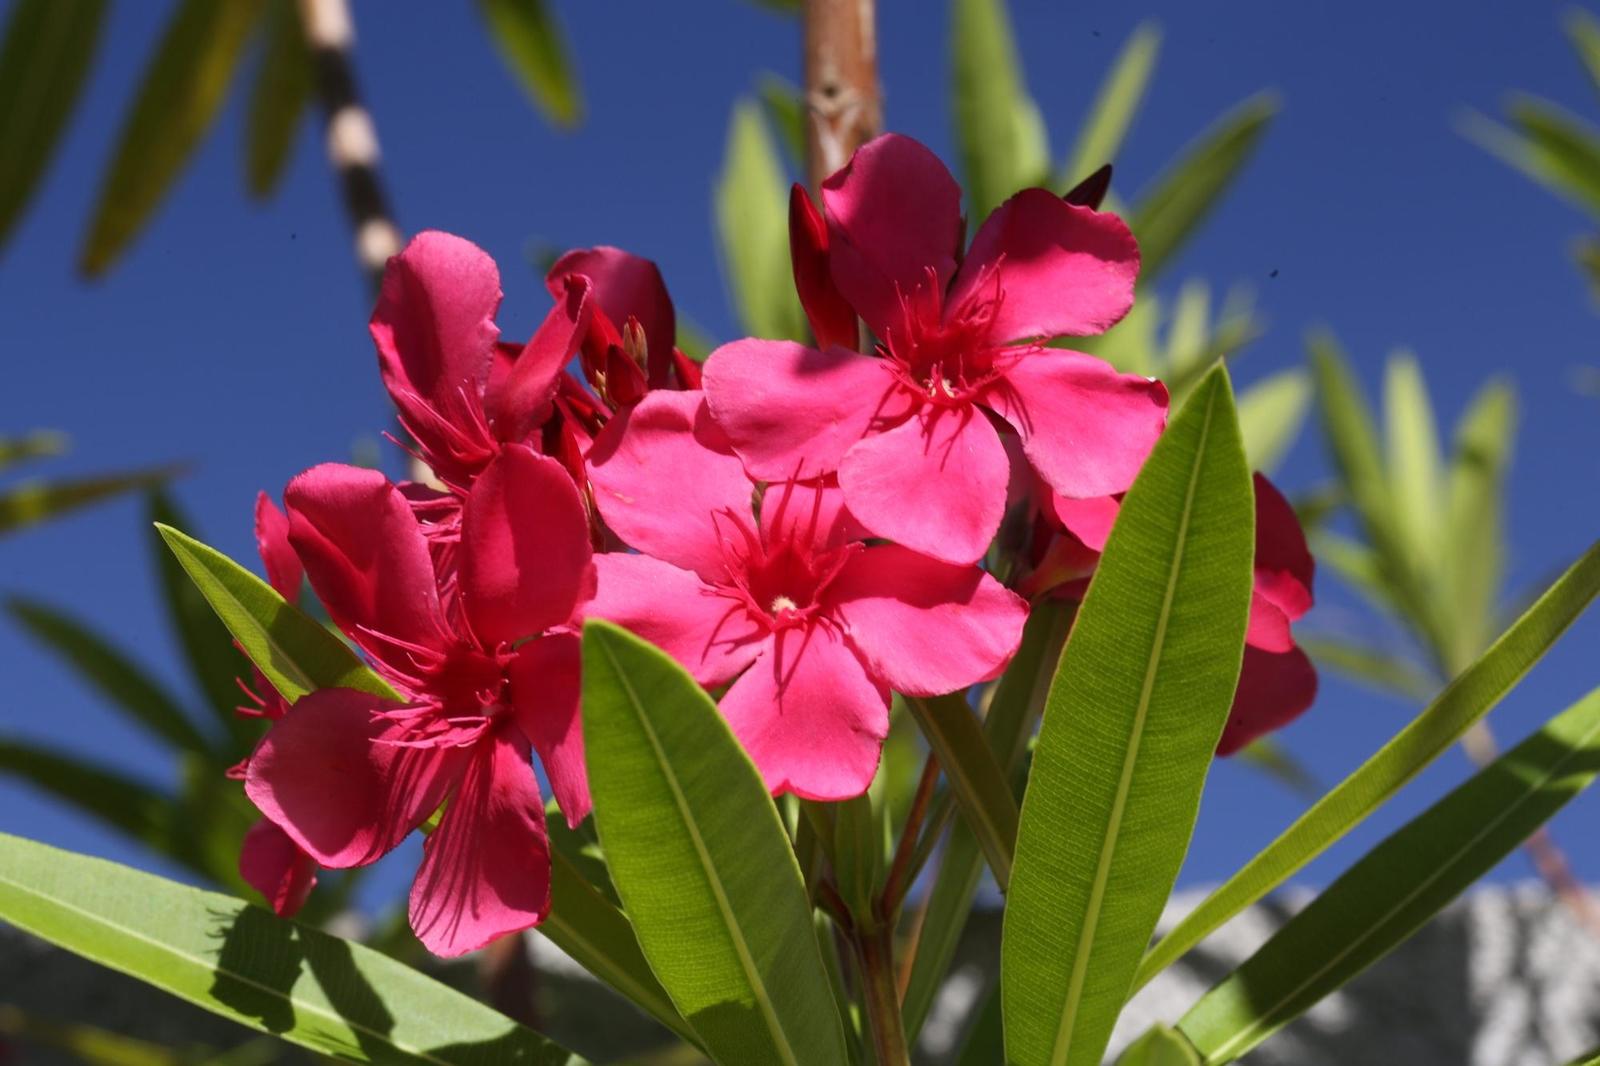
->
706 339 909 482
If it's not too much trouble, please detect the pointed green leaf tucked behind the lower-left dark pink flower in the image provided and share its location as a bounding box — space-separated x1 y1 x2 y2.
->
155 525 400 703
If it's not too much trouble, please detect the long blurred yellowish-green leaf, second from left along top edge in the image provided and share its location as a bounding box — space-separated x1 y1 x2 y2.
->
78 0 261 277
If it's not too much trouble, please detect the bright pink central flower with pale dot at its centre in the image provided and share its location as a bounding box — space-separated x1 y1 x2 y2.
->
587 392 1027 800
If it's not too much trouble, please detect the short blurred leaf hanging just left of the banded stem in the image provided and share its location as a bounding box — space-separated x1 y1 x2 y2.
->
245 0 312 198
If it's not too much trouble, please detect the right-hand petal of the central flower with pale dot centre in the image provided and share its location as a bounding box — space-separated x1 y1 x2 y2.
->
827 544 1027 696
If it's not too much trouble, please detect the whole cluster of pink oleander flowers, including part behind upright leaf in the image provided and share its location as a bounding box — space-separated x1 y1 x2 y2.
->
237 134 1315 956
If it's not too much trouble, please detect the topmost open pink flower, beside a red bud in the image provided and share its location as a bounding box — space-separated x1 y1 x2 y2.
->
704 134 1166 563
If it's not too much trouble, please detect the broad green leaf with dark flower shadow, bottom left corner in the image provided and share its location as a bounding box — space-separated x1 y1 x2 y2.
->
0 834 582 1066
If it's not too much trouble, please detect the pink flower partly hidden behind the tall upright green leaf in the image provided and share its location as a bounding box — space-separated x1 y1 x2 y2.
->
1019 474 1317 755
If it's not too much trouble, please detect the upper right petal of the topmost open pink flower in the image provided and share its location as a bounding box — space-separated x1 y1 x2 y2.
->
946 189 1139 341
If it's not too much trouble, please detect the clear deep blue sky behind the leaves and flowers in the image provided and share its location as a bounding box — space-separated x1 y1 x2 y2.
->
0 0 1600 887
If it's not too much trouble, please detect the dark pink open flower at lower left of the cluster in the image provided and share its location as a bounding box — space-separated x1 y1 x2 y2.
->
236 445 594 956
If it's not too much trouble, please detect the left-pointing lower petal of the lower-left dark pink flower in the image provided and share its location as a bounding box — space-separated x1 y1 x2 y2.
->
245 688 466 869
